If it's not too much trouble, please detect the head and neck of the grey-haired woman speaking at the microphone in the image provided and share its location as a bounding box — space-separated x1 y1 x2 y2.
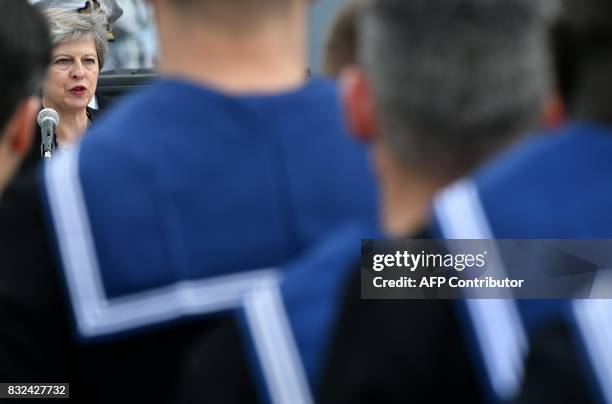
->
42 8 108 150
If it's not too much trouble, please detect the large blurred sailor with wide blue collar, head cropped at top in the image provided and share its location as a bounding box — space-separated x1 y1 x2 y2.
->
0 0 376 403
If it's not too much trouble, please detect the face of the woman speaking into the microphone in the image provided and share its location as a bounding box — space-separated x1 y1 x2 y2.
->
43 38 100 110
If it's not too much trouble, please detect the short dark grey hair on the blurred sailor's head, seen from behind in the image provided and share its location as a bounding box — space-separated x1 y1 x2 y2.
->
358 0 552 174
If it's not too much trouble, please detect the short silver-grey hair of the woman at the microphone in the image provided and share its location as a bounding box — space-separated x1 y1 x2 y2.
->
44 8 108 69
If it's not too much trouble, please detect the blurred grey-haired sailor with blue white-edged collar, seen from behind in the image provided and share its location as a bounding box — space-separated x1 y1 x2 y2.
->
172 0 552 404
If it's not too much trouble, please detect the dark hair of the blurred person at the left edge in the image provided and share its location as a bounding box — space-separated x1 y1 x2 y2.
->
0 0 51 133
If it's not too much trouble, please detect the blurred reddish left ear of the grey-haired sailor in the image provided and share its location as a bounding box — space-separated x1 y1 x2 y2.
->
340 66 378 143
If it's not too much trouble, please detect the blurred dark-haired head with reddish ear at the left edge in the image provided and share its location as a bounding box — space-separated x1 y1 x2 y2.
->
0 0 51 191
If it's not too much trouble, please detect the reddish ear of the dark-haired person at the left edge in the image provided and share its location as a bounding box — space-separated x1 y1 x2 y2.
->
4 97 40 156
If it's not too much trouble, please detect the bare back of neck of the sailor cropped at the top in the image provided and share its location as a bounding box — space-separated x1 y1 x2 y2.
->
149 0 310 93
